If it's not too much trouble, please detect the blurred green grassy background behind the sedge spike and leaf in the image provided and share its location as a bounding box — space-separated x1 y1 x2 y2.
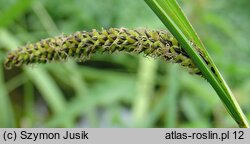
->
0 0 250 127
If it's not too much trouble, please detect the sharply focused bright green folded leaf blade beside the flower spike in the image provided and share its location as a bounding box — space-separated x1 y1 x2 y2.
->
145 0 249 127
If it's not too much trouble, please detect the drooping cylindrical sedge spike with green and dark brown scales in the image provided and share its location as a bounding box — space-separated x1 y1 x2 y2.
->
5 28 200 75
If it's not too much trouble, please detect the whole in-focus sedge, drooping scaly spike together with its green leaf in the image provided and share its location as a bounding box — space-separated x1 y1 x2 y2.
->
4 0 248 127
